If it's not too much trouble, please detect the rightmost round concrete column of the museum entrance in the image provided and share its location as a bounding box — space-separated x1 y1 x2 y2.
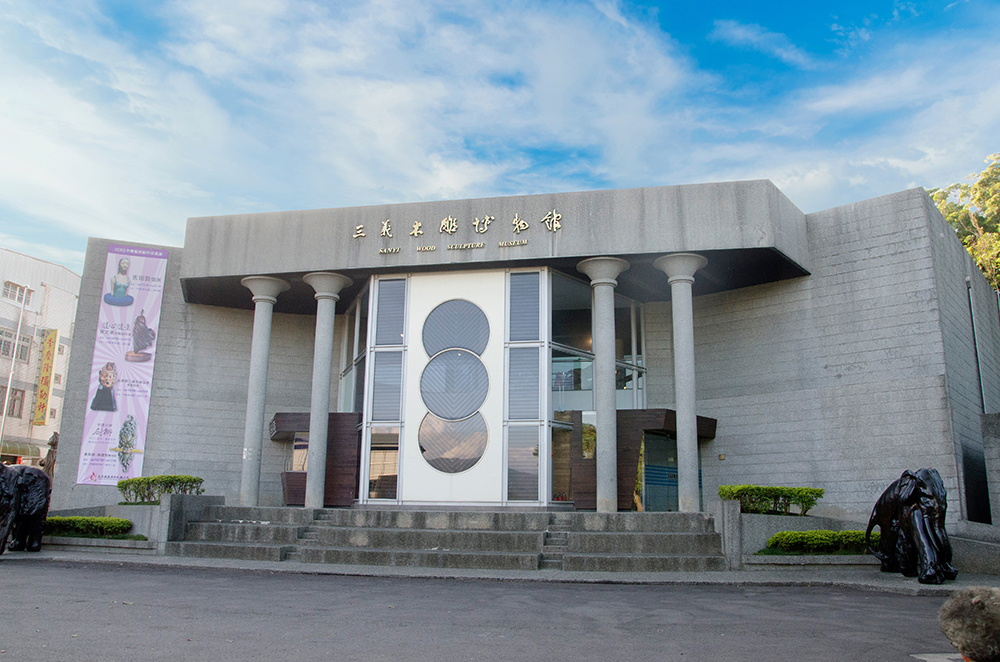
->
653 253 708 513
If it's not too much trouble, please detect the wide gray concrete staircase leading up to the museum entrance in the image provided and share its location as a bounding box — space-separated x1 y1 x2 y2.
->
166 506 726 572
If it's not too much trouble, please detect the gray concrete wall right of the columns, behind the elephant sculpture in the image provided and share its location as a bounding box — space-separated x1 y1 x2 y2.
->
646 190 968 521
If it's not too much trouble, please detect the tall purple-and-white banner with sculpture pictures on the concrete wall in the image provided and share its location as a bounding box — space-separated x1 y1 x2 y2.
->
76 244 167 485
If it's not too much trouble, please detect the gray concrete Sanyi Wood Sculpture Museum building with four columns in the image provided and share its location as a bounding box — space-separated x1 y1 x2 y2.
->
53 181 1000 523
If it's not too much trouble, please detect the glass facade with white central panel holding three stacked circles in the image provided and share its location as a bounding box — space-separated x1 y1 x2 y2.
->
348 269 645 503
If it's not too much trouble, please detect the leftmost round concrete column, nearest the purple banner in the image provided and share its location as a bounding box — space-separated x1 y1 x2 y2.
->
240 276 289 506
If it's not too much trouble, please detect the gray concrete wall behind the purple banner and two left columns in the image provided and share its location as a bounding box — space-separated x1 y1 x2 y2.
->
52 239 342 508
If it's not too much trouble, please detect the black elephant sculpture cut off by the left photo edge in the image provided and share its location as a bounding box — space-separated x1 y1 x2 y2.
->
0 464 52 554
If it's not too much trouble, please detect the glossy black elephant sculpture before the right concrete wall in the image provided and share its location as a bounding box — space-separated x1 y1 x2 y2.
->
865 469 958 584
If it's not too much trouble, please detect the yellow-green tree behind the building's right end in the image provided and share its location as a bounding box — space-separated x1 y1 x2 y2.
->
928 153 1000 290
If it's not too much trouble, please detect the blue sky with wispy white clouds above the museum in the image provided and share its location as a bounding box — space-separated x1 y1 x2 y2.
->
0 0 1000 272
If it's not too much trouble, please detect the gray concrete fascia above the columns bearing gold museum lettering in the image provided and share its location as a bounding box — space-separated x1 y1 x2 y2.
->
182 180 810 278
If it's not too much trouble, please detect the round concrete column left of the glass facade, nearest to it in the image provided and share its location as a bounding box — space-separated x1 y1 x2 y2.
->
302 272 352 508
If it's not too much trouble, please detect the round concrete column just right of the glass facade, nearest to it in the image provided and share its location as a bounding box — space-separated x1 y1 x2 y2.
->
576 257 629 513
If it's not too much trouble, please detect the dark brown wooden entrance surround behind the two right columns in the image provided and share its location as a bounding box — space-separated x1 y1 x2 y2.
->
570 409 716 511
